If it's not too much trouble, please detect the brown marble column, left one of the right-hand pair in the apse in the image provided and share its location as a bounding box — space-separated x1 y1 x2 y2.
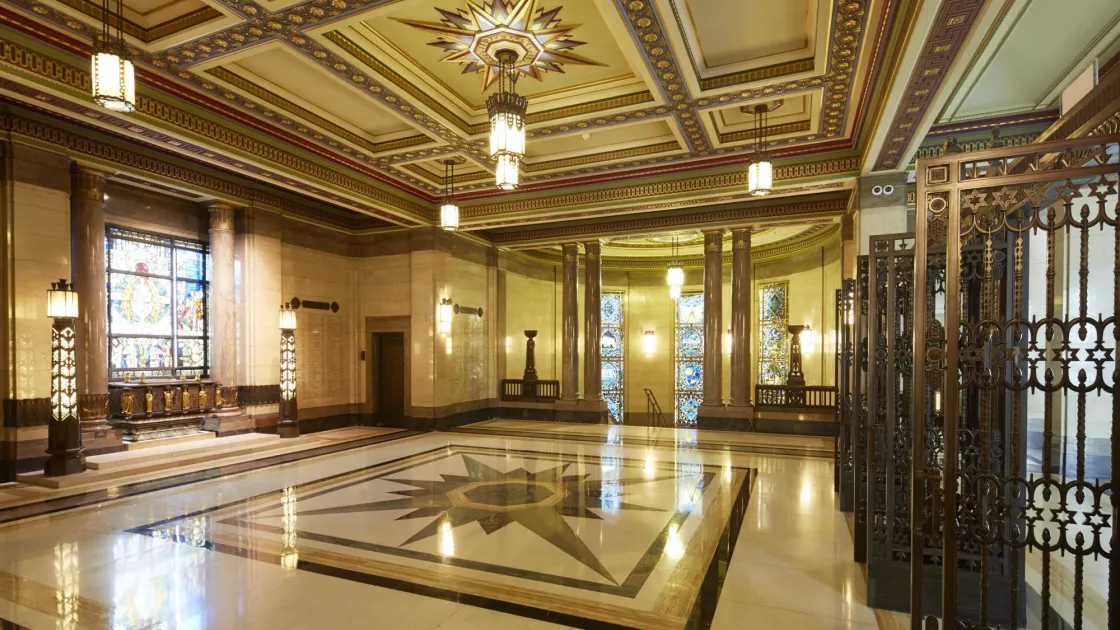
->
701 230 724 407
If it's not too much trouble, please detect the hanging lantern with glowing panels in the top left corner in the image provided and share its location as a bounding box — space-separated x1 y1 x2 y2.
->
90 0 137 113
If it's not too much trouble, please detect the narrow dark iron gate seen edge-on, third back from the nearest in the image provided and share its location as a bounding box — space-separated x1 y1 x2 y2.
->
850 256 869 563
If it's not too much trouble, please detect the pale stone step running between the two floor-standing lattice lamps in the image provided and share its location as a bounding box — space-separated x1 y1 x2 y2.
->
16 434 295 490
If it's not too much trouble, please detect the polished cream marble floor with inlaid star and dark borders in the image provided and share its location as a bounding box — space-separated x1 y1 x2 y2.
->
0 424 878 630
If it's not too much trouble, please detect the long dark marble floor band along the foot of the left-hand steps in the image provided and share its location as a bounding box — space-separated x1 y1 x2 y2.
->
0 429 424 529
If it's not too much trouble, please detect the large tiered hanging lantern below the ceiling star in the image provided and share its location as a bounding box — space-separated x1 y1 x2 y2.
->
486 49 529 191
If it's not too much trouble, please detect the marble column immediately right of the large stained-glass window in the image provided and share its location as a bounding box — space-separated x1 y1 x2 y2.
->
209 203 237 405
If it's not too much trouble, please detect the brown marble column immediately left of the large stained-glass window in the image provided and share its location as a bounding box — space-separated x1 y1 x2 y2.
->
71 164 111 433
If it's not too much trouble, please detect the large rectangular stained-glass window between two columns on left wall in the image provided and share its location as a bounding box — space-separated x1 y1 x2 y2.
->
105 228 209 379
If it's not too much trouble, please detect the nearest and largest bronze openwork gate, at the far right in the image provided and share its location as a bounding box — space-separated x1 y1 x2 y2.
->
909 136 1120 630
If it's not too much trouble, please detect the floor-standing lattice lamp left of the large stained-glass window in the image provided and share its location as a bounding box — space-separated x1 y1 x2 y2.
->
43 280 85 476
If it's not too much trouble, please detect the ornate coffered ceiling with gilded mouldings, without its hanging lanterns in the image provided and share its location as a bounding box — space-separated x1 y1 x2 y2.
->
0 0 913 238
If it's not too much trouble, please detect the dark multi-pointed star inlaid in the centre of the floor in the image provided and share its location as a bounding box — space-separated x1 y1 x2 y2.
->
300 455 675 584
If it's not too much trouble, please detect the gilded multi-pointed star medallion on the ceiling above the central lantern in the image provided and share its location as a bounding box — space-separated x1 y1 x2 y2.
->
398 0 603 89
